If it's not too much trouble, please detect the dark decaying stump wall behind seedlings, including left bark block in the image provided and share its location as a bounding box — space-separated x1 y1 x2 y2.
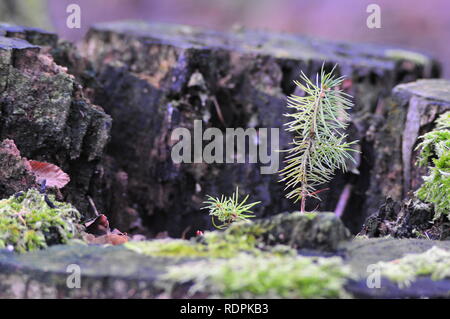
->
0 22 439 236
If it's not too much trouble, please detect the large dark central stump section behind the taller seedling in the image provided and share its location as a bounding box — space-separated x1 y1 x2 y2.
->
76 22 439 236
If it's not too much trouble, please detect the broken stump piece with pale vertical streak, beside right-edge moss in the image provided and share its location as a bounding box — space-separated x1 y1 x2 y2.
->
362 79 450 239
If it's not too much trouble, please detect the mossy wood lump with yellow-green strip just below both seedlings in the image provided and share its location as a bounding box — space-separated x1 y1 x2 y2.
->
125 212 350 258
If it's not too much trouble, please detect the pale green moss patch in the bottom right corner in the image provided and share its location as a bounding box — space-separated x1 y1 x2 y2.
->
377 246 450 286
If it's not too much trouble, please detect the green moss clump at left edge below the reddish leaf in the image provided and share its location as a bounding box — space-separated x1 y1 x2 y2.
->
0 189 80 252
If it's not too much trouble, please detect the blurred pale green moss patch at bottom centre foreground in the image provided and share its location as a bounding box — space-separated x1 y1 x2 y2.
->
165 253 352 298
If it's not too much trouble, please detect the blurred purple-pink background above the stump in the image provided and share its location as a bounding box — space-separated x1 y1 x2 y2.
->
0 0 450 78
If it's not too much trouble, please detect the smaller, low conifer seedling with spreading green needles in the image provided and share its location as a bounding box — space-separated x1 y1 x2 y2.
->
201 187 261 229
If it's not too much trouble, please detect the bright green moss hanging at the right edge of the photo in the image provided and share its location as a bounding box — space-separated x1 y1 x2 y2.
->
416 112 450 220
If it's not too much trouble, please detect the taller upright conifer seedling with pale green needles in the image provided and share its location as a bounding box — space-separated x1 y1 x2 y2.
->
279 66 357 213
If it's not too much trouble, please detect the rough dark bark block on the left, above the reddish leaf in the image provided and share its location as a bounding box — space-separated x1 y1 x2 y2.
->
0 24 111 215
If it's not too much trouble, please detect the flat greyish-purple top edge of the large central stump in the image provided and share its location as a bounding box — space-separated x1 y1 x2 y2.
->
86 20 436 70
